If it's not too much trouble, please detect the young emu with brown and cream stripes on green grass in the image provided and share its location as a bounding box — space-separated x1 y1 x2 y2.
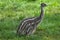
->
17 3 46 35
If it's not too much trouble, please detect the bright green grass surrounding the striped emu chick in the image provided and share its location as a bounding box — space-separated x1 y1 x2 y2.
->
0 0 60 40
